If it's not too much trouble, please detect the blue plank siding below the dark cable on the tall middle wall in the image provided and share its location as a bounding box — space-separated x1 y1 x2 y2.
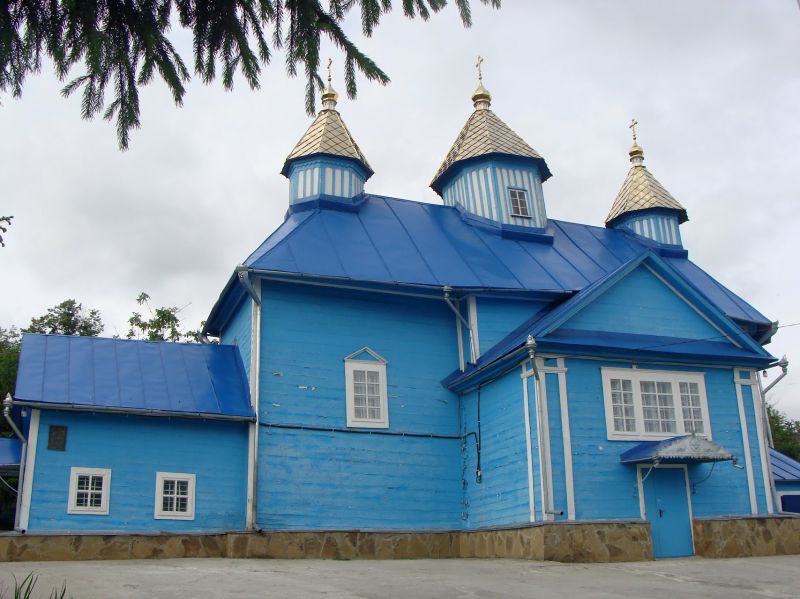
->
258 428 461 530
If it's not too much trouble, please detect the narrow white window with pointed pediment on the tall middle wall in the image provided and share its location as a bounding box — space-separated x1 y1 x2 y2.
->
344 348 389 428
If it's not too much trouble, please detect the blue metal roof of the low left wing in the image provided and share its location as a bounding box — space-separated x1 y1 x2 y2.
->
15 333 255 420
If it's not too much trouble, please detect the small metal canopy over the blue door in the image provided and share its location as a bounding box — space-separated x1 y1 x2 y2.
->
619 435 736 464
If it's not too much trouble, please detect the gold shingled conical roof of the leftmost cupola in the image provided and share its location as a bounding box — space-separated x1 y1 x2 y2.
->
281 86 373 179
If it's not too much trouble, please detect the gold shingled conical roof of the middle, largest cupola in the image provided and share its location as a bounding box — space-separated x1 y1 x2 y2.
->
431 108 552 193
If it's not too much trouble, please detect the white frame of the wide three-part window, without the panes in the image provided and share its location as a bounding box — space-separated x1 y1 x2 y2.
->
600 368 711 441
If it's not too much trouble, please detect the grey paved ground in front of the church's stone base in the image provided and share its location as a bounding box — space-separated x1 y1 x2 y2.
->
0 556 800 599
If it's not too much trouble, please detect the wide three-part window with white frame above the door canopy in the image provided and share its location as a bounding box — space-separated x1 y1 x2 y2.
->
602 368 711 439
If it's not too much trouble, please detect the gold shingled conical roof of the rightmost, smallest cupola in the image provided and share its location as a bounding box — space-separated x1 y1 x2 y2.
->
606 143 689 226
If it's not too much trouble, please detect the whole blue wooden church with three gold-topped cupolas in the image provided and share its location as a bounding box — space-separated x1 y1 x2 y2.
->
13 71 780 556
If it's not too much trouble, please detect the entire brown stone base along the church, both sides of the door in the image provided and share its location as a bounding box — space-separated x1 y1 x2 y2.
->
0 518 800 562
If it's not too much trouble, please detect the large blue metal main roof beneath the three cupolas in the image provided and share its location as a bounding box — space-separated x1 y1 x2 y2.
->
206 194 771 334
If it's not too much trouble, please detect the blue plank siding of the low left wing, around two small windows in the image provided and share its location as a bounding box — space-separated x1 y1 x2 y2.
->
28 411 247 532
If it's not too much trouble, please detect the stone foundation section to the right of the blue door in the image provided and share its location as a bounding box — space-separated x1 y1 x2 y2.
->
692 516 800 557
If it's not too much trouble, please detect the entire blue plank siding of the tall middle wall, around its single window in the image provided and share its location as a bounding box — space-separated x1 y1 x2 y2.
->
258 282 461 529
